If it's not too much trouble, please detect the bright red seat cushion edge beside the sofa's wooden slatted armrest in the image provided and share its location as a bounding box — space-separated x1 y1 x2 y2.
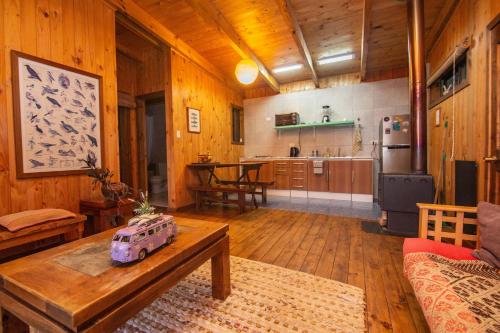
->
403 238 477 260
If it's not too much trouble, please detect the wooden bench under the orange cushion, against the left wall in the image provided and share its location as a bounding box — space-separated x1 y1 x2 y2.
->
0 215 87 258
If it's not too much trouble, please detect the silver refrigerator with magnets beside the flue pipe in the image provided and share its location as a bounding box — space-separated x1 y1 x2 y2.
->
380 114 411 173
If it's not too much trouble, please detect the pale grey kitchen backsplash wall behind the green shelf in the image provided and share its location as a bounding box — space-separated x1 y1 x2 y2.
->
244 78 409 157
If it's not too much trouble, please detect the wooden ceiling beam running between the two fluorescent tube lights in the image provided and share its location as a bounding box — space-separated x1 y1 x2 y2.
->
276 0 319 88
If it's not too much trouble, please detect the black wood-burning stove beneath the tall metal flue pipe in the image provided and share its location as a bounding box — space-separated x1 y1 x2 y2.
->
378 173 434 236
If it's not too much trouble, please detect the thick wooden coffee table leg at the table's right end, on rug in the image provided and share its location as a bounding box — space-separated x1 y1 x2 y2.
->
212 236 231 300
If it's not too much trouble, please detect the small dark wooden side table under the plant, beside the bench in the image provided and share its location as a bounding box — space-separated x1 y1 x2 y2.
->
80 199 135 236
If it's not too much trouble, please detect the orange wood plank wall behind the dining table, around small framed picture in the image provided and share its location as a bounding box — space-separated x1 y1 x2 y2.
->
167 50 243 208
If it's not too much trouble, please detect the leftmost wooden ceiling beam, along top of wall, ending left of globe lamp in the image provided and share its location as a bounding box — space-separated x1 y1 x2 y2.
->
106 0 235 86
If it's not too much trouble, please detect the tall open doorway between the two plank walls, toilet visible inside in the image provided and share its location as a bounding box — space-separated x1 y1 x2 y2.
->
116 15 168 207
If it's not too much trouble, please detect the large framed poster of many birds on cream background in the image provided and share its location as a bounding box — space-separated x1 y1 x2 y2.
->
11 51 103 178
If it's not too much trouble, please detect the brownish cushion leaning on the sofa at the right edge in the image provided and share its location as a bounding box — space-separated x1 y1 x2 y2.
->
473 202 500 268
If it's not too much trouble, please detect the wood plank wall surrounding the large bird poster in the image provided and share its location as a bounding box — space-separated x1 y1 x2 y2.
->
0 0 119 215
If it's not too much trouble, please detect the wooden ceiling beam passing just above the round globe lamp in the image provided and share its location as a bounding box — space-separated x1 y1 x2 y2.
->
185 0 280 92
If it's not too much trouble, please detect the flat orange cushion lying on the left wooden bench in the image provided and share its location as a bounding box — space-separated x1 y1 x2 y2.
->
0 208 76 232
